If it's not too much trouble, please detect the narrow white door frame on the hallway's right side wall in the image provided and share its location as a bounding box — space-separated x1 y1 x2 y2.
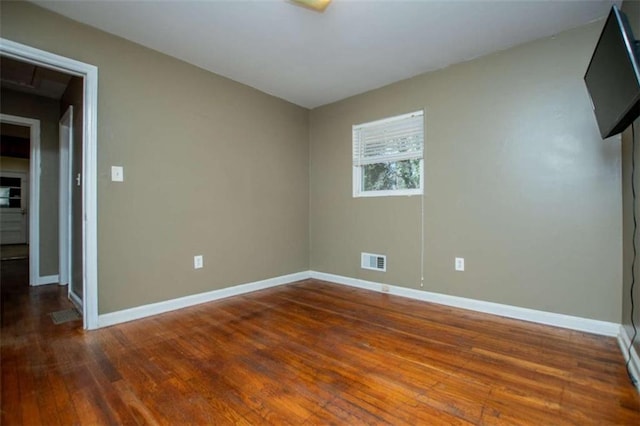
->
58 105 73 295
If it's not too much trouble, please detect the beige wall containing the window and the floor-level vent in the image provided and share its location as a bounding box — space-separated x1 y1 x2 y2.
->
310 22 622 322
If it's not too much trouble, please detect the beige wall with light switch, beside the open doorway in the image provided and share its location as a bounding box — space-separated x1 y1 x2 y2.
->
0 2 309 314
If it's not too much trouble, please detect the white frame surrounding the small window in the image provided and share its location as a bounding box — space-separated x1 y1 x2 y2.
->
352 110 424 198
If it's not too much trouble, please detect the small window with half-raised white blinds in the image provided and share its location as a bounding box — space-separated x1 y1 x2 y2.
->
353 111 424 197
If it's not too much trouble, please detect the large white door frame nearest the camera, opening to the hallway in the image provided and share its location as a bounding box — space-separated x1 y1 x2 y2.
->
0 38 98 330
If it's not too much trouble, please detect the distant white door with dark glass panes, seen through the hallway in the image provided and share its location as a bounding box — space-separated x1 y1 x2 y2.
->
0 171 29 244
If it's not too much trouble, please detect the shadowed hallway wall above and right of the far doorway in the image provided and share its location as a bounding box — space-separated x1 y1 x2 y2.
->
0 90 60 276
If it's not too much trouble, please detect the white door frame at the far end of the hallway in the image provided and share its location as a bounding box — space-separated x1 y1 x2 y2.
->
0 114 40 285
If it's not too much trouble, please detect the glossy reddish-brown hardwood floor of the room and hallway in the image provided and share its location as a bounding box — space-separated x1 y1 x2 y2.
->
1 261 640 425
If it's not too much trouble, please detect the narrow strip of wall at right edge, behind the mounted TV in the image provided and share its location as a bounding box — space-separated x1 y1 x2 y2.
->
622 0 640 353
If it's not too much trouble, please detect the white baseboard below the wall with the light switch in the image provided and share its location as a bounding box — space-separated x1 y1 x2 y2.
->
98 271 309 328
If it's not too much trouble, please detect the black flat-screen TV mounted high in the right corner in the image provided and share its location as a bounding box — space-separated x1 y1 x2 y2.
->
584 6 640 139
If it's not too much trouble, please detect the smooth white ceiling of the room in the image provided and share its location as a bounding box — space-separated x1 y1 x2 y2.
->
34 0 621 108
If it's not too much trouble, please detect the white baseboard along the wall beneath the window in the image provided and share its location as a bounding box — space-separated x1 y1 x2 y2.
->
310 271 620 336
